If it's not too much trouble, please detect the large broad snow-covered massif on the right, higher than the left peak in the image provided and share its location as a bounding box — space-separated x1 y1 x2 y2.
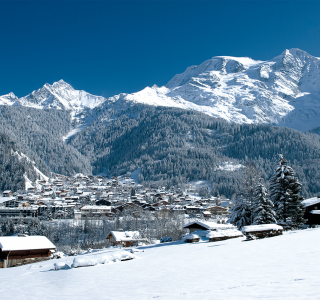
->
119 49 320 131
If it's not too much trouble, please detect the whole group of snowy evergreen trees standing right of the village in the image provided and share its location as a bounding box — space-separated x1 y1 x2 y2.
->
229 155 305 229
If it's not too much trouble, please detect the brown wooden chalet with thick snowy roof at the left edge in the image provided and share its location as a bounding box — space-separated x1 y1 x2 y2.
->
0 235 56 268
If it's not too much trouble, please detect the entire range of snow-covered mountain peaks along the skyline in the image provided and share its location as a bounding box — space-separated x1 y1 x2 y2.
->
0 49 320 133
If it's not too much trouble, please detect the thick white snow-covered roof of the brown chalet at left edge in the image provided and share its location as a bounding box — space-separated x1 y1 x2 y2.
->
0 236 56 251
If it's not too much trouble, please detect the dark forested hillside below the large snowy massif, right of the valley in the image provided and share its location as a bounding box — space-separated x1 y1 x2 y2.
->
69 107 320 197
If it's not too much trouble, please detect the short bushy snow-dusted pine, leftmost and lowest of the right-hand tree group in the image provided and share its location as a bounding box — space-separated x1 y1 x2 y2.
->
228 197 252 229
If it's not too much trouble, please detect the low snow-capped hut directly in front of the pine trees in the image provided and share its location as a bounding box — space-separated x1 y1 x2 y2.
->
241 224 283 240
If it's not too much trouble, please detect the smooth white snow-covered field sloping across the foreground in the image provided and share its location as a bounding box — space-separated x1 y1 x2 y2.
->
0 229 320 300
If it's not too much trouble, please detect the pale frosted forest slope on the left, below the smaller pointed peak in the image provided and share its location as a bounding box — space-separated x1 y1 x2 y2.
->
0 106 91 176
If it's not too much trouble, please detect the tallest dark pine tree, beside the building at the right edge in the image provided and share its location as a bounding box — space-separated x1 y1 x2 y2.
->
269 154 304 228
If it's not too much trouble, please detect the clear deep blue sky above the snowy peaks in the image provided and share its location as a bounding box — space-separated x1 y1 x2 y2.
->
0 0 320 97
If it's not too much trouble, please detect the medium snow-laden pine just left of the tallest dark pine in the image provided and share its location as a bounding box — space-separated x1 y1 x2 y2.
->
252 179 277 225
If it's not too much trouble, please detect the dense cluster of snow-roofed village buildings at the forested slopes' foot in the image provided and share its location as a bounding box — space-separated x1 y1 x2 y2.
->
0 174 232 220
